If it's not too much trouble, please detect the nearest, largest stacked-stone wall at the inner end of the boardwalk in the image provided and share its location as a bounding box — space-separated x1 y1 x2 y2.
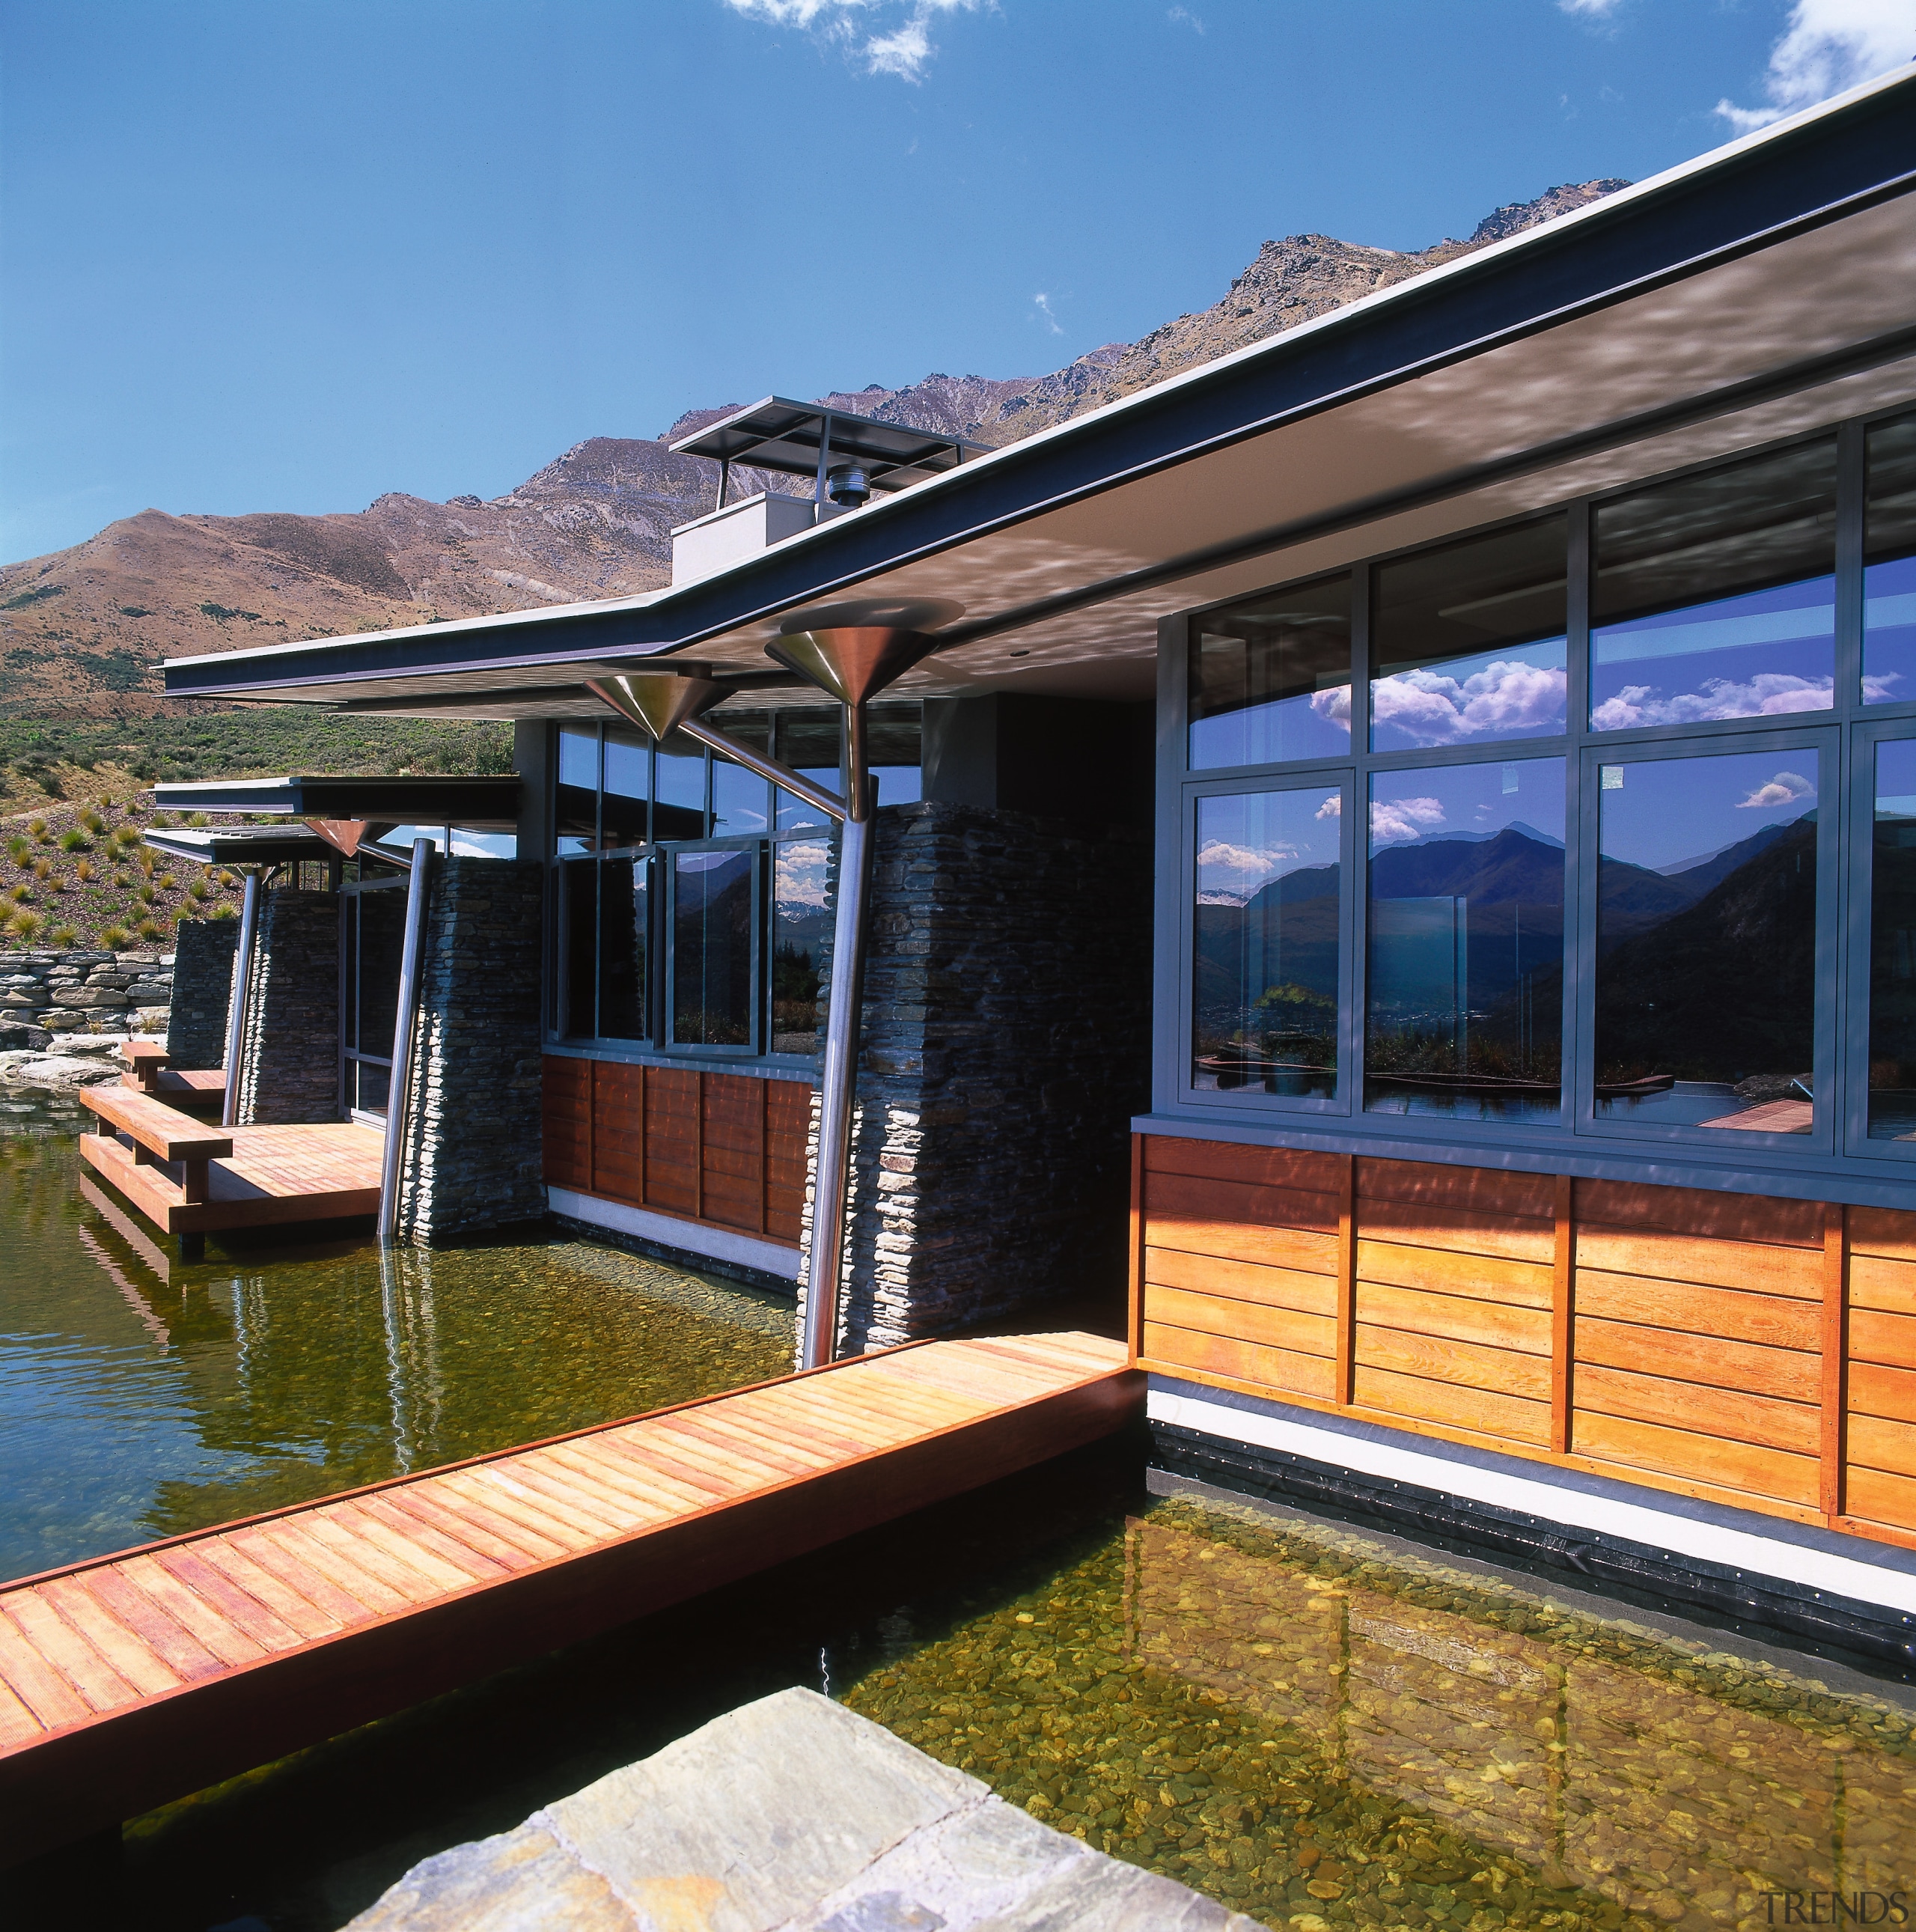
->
805 804 1151 1353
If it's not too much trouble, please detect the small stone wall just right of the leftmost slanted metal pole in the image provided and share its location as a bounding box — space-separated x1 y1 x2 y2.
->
240 887 340 1127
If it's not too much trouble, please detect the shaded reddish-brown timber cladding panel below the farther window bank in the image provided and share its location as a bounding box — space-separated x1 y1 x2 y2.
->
545 1055 811 1248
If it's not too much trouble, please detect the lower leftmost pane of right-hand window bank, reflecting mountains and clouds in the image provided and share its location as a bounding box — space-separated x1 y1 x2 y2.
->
1192 784 1344 1100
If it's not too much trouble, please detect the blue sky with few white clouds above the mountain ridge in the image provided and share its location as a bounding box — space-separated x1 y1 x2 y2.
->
0 0 1916 560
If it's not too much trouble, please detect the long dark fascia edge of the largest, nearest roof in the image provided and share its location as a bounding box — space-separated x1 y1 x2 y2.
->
166 77 1916 710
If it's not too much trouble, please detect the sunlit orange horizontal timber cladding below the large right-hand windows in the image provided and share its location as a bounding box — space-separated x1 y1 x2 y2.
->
1132 1136 1916 1546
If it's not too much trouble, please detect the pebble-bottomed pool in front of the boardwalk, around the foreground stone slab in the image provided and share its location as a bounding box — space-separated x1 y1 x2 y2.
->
105 1449 1916 1932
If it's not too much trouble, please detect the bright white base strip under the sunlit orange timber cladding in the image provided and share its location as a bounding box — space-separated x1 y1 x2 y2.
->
1147 1389 1916 1613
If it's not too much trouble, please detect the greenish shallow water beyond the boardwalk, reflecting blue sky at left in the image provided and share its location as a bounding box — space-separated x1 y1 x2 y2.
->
0 1090 792 1576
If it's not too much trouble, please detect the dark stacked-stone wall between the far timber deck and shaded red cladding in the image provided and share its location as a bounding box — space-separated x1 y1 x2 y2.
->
400 858 545 1243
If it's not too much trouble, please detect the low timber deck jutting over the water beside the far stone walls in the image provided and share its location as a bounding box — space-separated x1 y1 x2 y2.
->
79 1121 385 1234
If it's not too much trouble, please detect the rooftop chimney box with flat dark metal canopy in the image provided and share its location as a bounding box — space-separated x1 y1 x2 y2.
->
670 396 985 585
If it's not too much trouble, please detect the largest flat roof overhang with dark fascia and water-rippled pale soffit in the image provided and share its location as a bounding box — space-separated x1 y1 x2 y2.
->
166 71 1916 717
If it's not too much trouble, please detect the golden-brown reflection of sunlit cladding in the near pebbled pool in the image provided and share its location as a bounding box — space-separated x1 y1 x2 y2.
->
1128 1517 1916 1932
